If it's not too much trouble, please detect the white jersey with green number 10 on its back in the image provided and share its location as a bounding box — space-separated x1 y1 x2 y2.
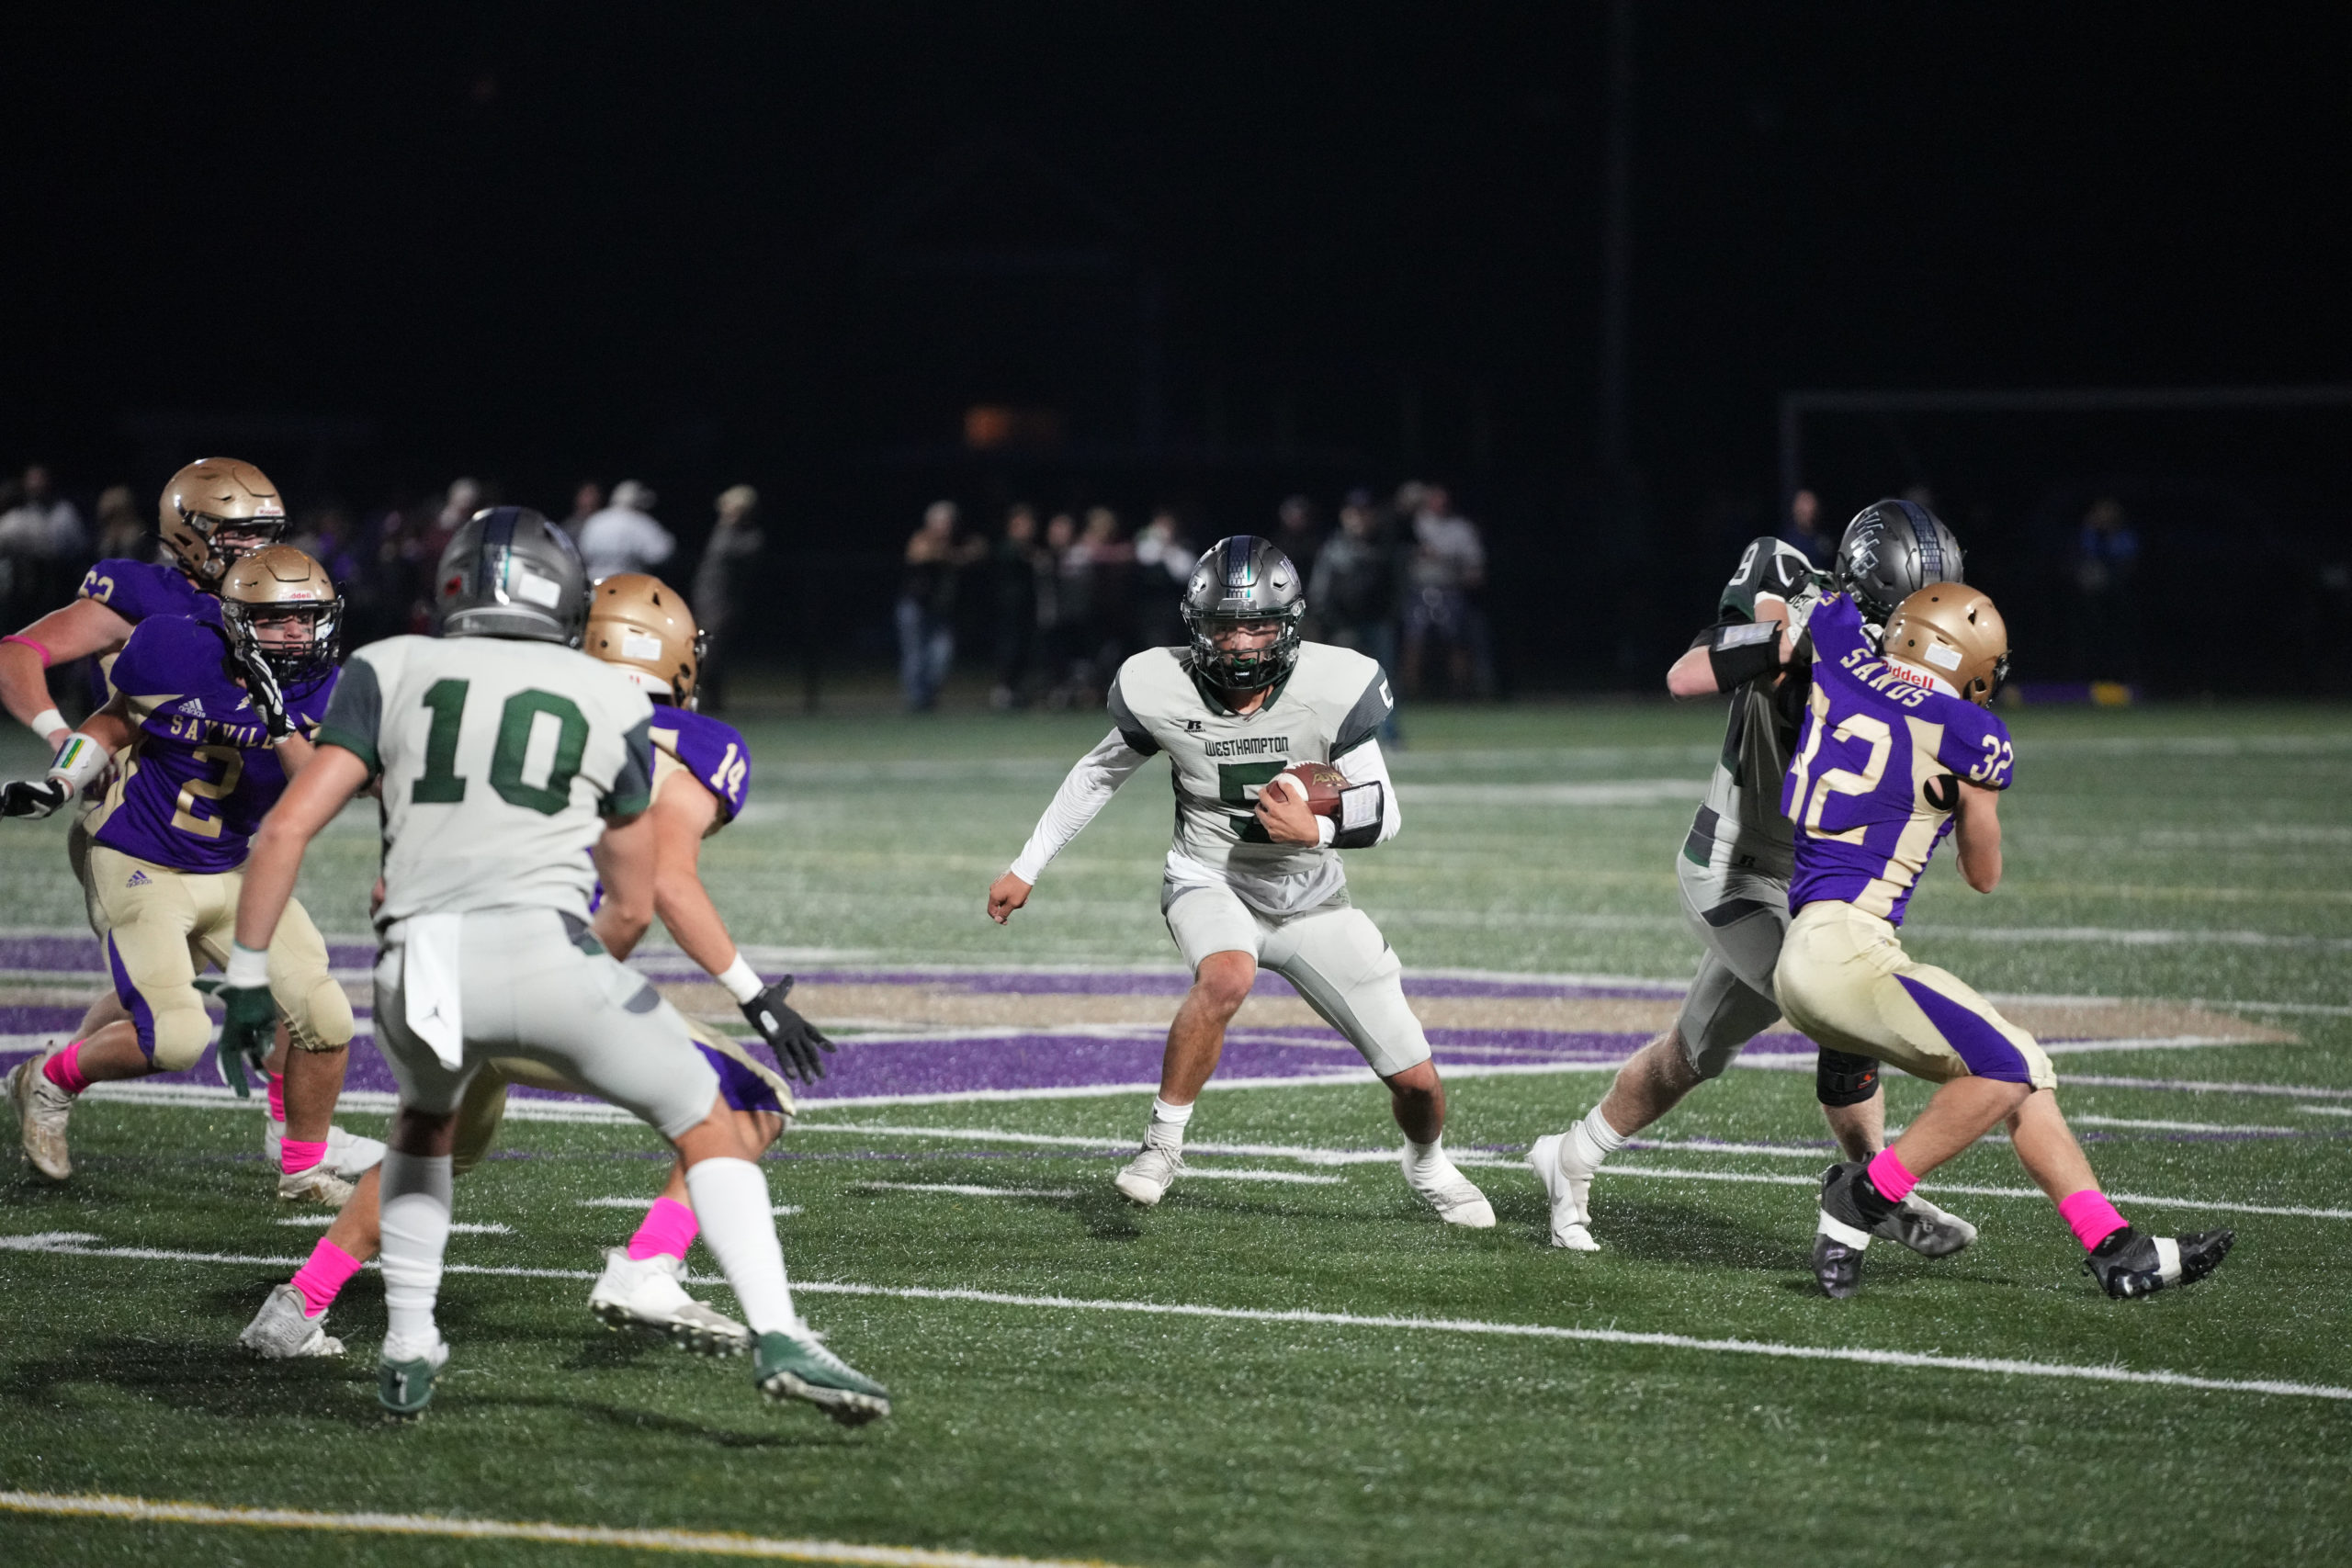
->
318 637 654 931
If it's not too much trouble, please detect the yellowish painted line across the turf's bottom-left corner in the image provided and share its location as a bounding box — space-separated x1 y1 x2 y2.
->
0 1493 1103 1568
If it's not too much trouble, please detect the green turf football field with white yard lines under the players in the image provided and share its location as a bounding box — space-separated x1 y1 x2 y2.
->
0 703 2352 1565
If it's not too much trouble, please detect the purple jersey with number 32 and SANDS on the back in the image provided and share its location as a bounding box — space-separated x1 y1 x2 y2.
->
1781 594 2013 926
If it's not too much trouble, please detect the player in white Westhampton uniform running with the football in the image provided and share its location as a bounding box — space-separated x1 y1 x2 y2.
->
988 534 1494 1227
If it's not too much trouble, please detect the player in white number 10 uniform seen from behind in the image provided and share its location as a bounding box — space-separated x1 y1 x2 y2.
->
221 505 889 1425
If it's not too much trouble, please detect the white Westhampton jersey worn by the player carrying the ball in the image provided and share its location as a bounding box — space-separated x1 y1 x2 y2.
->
1108 642 1395 915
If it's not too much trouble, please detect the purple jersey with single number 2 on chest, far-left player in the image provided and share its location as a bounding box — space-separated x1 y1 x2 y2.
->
92 616 341 874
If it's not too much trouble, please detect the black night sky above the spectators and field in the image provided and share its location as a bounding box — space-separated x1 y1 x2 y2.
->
0 5 2352 682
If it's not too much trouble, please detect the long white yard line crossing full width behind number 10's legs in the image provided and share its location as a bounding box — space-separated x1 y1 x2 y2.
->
0 1241 2352 1410
